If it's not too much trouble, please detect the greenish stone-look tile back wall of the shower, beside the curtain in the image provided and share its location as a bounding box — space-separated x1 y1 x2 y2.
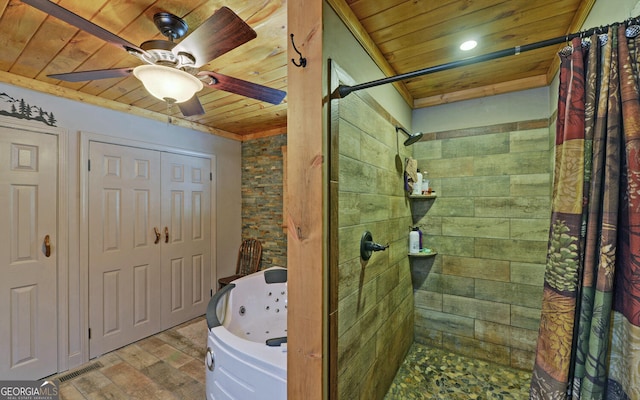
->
412 120 553 369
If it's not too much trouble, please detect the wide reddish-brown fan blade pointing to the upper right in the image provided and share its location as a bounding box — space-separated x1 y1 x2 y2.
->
173 7 257 68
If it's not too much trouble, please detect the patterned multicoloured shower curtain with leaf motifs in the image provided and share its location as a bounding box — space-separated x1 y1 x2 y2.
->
530 26 640 399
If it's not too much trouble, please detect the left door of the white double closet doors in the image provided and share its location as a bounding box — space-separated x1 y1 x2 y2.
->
89 142 161 357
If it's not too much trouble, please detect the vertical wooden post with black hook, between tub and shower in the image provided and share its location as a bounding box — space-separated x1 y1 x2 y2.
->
286 0 326 400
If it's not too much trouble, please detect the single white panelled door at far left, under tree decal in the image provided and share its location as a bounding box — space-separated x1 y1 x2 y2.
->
0 127 58 380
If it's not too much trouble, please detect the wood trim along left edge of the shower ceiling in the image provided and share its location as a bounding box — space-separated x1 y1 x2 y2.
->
327 0 414 107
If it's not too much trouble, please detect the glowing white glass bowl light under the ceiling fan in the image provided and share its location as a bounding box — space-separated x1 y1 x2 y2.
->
133 65 203 103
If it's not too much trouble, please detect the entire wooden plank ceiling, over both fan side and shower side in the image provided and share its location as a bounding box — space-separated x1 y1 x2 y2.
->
0 0 594 140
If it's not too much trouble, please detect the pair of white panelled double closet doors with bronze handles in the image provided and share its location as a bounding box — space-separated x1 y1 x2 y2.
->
89 142 211 357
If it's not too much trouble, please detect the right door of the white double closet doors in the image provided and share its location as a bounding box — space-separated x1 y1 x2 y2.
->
162 153 211 329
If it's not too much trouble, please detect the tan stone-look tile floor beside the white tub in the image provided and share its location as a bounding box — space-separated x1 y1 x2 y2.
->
55 318 207 400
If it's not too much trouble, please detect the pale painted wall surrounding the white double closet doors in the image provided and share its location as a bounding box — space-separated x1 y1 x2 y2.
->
0 83 242 368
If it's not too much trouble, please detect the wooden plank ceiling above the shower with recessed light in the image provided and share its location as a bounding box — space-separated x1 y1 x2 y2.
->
328 0 595 108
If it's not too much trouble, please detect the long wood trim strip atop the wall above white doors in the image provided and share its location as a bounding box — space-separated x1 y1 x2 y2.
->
0 71 242 141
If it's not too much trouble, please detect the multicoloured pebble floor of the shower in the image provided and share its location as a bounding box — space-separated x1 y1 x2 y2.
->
385 343 531 400
